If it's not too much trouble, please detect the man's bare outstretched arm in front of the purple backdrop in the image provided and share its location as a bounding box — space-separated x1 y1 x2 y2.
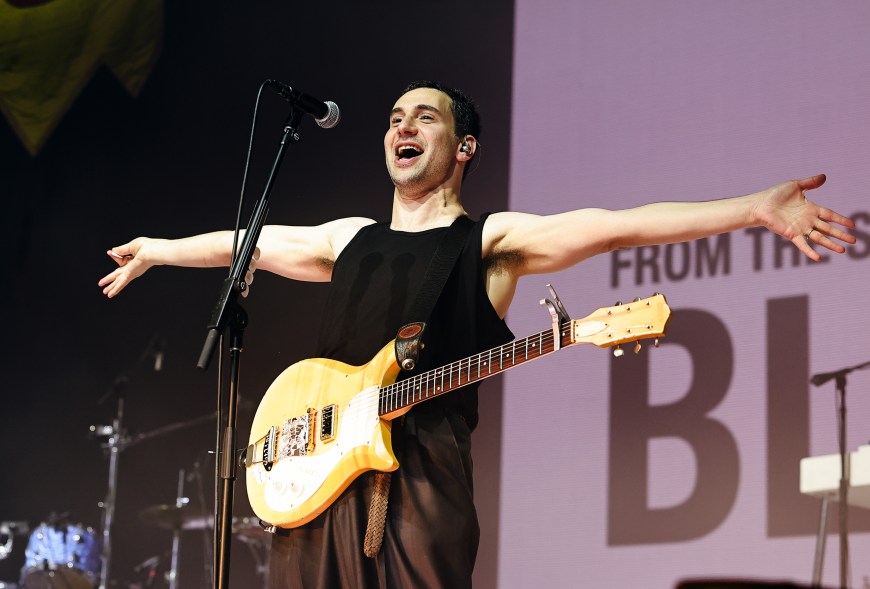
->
485 175 855 278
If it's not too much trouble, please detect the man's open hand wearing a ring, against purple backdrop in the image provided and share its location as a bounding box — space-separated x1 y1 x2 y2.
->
754 174 855 261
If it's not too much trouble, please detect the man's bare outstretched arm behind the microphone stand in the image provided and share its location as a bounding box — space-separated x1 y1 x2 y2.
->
99 217 373 298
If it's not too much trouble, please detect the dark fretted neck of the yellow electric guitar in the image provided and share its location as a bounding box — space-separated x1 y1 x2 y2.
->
378 321 575 417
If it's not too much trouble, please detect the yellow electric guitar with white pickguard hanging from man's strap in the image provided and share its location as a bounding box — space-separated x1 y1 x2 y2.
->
243 288 670 528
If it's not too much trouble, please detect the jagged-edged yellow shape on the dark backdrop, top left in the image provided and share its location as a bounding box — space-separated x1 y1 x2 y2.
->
0 0 163 156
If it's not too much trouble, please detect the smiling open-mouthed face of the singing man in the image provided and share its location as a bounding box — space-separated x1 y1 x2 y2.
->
384 88 459 192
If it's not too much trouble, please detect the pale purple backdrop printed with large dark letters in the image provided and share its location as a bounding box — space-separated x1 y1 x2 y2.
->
499 0 870 587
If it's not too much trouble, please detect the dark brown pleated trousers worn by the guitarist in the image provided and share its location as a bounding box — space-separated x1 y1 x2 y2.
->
270 406 480 589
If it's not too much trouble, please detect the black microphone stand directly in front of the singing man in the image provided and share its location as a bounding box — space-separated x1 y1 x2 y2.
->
197 105 305 589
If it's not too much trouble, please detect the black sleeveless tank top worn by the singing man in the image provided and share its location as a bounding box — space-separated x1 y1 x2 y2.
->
317 214 513 428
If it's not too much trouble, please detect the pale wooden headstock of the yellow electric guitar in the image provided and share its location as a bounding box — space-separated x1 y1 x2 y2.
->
570 294 671 356
